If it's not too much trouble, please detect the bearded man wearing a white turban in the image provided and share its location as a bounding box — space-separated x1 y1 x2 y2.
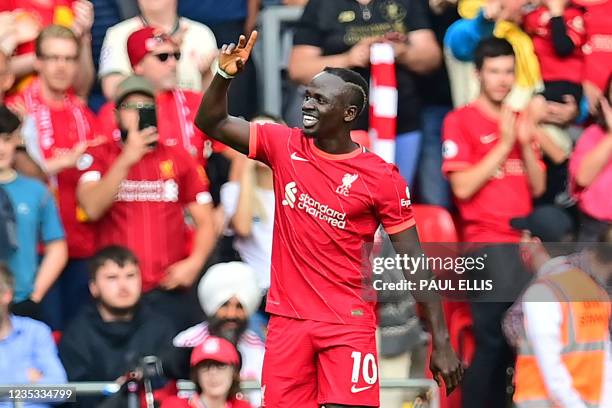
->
164 262 265 406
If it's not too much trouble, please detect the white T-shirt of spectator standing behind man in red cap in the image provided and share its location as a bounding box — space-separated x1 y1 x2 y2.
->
98 16 217 92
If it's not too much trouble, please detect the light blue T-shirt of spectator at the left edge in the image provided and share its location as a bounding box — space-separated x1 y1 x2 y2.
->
0 174 64 303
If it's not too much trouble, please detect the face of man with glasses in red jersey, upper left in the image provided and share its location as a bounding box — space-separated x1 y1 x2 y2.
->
35 38 79 92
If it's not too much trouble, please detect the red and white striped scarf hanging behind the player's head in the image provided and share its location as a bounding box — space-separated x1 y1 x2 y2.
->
369 43 397 163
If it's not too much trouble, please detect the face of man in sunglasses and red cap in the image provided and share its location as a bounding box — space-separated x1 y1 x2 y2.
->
134 41 180 91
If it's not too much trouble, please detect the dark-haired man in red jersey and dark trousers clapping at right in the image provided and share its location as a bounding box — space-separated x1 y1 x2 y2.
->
442 38 546 408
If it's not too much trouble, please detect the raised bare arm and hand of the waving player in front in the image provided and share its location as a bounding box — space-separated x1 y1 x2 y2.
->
195 31 257 154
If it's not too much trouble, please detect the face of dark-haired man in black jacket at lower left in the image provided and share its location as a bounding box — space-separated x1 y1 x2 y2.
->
89 261 142 312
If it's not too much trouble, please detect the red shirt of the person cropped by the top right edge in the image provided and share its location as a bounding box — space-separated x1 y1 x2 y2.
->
523 6 586 84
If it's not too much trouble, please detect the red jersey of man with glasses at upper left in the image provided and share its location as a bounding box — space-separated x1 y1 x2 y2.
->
11 92 99 258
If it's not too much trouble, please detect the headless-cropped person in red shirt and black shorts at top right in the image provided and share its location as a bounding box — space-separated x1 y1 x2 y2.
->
523 0 586 103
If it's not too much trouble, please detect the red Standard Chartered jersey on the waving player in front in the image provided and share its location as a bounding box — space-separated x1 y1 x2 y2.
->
249 123 415 326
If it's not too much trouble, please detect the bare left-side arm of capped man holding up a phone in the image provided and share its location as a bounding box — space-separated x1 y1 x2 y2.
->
77 128 157 221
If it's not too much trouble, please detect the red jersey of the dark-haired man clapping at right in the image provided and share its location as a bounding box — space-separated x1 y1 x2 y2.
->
442 104 544 242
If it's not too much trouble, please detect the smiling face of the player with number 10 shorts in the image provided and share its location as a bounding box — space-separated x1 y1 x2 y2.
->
302 72 354 136
